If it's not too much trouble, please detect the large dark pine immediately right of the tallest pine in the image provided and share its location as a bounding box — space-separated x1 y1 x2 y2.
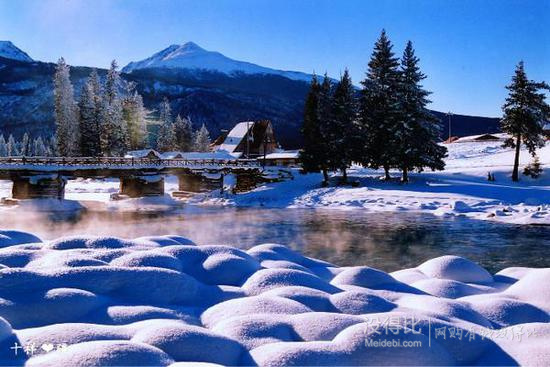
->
394 41 447 182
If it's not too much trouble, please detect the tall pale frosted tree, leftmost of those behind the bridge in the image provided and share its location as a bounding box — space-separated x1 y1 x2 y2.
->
54 58 80 157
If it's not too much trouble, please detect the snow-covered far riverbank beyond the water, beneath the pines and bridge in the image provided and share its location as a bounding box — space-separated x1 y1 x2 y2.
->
0 141 550 225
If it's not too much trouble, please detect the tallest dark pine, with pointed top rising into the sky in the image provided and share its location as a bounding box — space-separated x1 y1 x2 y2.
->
359 30 399 180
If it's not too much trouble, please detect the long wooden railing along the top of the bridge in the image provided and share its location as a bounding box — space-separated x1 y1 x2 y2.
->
0 157 260 168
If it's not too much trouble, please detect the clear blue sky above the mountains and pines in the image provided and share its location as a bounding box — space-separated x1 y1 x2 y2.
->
0 0 550 116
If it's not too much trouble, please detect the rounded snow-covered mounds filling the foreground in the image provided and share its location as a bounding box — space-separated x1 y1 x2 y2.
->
0 231 550 367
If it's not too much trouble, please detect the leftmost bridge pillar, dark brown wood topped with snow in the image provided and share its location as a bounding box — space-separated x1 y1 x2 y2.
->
11 174 67 200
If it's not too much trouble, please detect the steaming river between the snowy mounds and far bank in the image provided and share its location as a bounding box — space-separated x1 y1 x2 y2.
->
0 207 550 272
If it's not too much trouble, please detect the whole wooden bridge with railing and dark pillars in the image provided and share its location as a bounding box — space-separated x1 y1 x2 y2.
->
0 157 268 199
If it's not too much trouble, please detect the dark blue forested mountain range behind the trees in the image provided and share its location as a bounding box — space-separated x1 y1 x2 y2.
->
0 44 498 149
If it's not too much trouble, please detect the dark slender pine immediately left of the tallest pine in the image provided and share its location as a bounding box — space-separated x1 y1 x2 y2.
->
326 69 358 183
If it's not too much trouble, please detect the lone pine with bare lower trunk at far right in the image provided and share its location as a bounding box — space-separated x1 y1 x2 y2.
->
500 61 550 181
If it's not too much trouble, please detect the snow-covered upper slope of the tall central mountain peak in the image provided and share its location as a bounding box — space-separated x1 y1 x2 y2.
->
122 42 311 81
